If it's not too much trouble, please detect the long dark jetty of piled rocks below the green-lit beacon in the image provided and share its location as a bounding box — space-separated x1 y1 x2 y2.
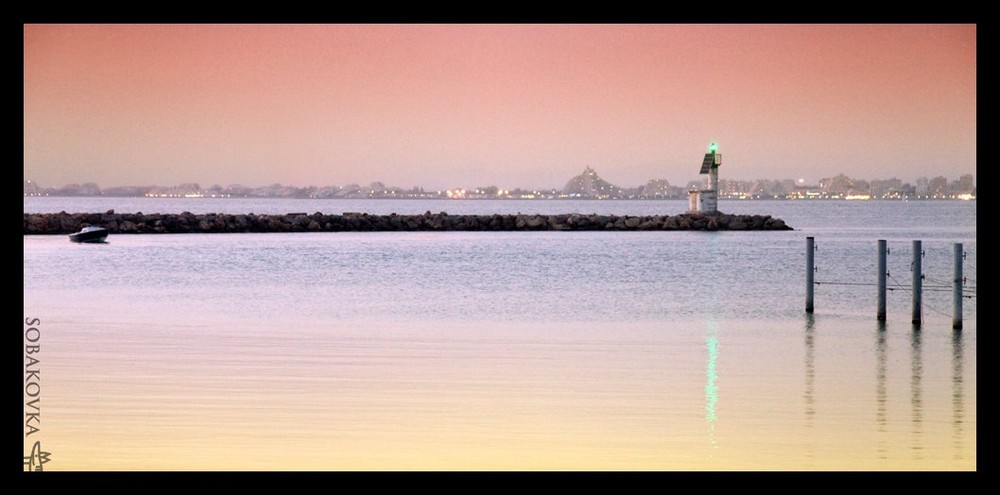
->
24 210 793 235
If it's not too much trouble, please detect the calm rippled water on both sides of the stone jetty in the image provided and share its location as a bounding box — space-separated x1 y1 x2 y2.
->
24 198 977 470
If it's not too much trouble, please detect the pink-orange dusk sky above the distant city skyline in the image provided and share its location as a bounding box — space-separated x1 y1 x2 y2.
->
24 24 977 190
